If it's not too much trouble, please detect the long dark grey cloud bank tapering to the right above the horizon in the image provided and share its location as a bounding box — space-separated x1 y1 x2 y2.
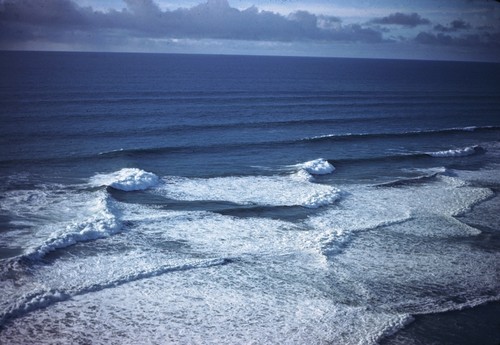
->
0 0 382 45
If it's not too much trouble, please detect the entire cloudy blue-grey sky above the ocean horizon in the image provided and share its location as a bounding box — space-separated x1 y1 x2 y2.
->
0 0 500 62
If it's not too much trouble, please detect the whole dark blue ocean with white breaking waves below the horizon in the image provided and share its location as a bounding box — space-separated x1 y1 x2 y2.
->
0 52 500 345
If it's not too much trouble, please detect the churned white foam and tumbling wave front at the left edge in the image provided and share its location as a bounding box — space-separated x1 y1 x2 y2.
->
0 185 121 254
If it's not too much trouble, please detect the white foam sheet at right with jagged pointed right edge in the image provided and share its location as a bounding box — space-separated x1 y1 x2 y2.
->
307 176 493 255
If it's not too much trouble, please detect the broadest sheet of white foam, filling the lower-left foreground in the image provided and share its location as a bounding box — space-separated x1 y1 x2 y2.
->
0 204 336 338
